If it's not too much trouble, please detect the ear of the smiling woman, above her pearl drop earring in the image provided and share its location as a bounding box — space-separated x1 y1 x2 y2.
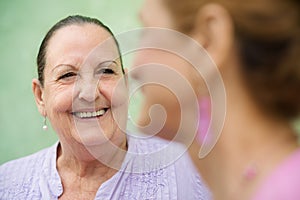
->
32 79 47 117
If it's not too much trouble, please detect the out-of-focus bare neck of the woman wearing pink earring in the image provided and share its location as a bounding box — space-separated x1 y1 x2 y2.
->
190 87 297 200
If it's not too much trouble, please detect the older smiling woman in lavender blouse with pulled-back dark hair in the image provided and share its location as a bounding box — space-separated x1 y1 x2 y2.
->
0 15 209 200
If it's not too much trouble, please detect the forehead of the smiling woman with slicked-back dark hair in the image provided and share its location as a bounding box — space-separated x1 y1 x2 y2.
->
46 23 118 66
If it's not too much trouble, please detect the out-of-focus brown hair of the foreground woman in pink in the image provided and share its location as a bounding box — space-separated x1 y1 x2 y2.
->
163 0 300 120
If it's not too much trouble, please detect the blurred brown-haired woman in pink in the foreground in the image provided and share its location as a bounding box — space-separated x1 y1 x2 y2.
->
133 0 300 200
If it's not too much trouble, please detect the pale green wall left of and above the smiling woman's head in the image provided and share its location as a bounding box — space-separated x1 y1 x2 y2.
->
0 0 141 164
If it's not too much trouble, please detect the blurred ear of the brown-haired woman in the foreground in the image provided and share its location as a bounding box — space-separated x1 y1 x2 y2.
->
192 3 234 67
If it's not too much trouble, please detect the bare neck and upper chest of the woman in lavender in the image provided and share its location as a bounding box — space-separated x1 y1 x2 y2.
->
56 138 127 199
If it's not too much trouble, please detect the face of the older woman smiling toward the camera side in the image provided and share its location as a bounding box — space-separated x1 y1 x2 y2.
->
42 24 127 146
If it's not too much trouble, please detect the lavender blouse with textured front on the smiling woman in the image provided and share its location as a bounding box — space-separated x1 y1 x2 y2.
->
0 136 211 200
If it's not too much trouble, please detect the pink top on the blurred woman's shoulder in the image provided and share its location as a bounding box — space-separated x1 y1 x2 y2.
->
252 149 300 200
